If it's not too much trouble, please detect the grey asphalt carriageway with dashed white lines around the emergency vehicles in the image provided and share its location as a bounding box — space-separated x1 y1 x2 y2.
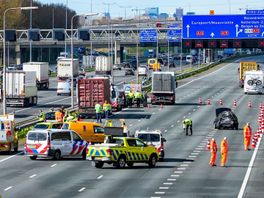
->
0 56 264 198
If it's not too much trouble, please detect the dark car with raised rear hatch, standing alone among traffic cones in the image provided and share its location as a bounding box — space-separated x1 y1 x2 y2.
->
214 108 238 130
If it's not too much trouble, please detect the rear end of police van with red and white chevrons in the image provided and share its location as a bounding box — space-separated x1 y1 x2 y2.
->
25 131 49 155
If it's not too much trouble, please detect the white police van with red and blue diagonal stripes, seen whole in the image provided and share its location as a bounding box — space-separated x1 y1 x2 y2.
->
24 129 88 160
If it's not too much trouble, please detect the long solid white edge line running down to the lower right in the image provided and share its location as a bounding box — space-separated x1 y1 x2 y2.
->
237 136 262 198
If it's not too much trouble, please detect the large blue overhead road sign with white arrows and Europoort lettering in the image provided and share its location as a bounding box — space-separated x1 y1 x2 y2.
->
182 15 264 39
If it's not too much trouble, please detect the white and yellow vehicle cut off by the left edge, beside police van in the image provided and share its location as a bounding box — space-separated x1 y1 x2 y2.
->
0 114 18 152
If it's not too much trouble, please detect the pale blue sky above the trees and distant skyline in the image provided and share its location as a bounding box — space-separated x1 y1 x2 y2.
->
38 0 264 18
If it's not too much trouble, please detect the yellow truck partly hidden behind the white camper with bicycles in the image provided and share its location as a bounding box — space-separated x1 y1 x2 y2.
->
238 62 259 88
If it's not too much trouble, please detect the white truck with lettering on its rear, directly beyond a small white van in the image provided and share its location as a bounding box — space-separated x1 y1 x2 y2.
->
57 58 79 78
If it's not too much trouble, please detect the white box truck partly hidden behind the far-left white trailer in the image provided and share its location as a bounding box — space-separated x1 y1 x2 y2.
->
23 62 49 89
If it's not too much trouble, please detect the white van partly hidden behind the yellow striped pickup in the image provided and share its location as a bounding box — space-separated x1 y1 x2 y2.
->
135 130 166 160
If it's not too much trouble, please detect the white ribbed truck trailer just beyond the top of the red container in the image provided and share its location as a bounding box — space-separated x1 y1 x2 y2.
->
95 56 113 75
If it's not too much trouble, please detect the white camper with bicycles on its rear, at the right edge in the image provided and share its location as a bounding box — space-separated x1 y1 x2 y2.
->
244 70 264 94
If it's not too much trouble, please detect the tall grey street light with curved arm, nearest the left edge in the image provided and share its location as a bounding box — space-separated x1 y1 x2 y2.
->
3 6 38 115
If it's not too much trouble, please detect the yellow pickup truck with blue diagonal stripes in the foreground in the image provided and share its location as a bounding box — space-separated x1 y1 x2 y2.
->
87 137 158 168
